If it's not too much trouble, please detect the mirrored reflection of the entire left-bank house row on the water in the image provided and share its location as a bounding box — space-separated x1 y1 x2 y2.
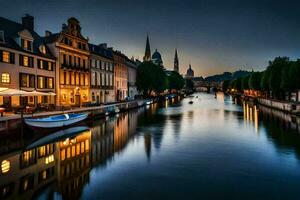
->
0 110 146 199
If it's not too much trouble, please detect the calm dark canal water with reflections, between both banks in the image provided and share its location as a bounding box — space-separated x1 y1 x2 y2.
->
0 93 300 200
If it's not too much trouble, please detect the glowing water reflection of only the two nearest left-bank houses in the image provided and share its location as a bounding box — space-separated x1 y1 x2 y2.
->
0 128 91 199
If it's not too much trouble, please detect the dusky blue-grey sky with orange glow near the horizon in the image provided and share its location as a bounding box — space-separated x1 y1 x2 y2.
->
0 0 300 76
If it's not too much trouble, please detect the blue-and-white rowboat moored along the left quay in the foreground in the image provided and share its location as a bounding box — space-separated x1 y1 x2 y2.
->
25 113 88 128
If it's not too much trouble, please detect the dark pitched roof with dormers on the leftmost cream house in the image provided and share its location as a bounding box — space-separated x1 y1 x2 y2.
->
0 17 55 59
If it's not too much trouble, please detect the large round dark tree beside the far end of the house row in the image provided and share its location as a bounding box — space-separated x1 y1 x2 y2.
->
136 62 166 96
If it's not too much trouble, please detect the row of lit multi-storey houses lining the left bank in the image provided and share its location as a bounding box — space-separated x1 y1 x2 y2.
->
0 15 139 107
